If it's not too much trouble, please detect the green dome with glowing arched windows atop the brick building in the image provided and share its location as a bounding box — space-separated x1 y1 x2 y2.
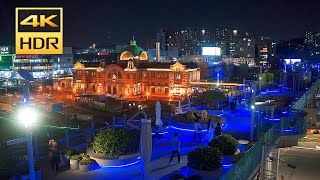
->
120 39 148 60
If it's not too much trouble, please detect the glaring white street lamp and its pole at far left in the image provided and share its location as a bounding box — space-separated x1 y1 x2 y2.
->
17 106 37 180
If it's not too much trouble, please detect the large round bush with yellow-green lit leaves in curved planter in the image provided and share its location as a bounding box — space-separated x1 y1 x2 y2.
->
93 128 140 157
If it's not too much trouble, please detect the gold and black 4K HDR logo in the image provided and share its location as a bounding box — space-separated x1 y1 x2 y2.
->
16 8 63 54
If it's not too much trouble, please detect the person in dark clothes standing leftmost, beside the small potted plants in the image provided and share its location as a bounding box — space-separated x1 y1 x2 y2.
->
49 140 60 173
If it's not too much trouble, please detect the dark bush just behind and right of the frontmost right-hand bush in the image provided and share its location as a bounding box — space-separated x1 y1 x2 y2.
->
208 134 238 155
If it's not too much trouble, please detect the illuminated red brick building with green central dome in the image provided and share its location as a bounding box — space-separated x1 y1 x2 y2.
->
56 40 200 98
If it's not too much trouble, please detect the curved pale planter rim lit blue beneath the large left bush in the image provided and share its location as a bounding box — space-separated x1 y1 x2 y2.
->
87 148 140 167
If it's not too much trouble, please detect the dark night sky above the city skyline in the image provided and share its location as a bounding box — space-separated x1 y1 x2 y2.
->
0 0 320 47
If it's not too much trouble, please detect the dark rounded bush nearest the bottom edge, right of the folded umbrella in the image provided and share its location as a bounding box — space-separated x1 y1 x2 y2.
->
188 147 222 171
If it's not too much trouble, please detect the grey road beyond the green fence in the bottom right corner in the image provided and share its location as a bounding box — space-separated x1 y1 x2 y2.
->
278 147 320 180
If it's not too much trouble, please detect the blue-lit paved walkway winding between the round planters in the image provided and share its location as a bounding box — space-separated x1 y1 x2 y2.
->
43 107 250 180
